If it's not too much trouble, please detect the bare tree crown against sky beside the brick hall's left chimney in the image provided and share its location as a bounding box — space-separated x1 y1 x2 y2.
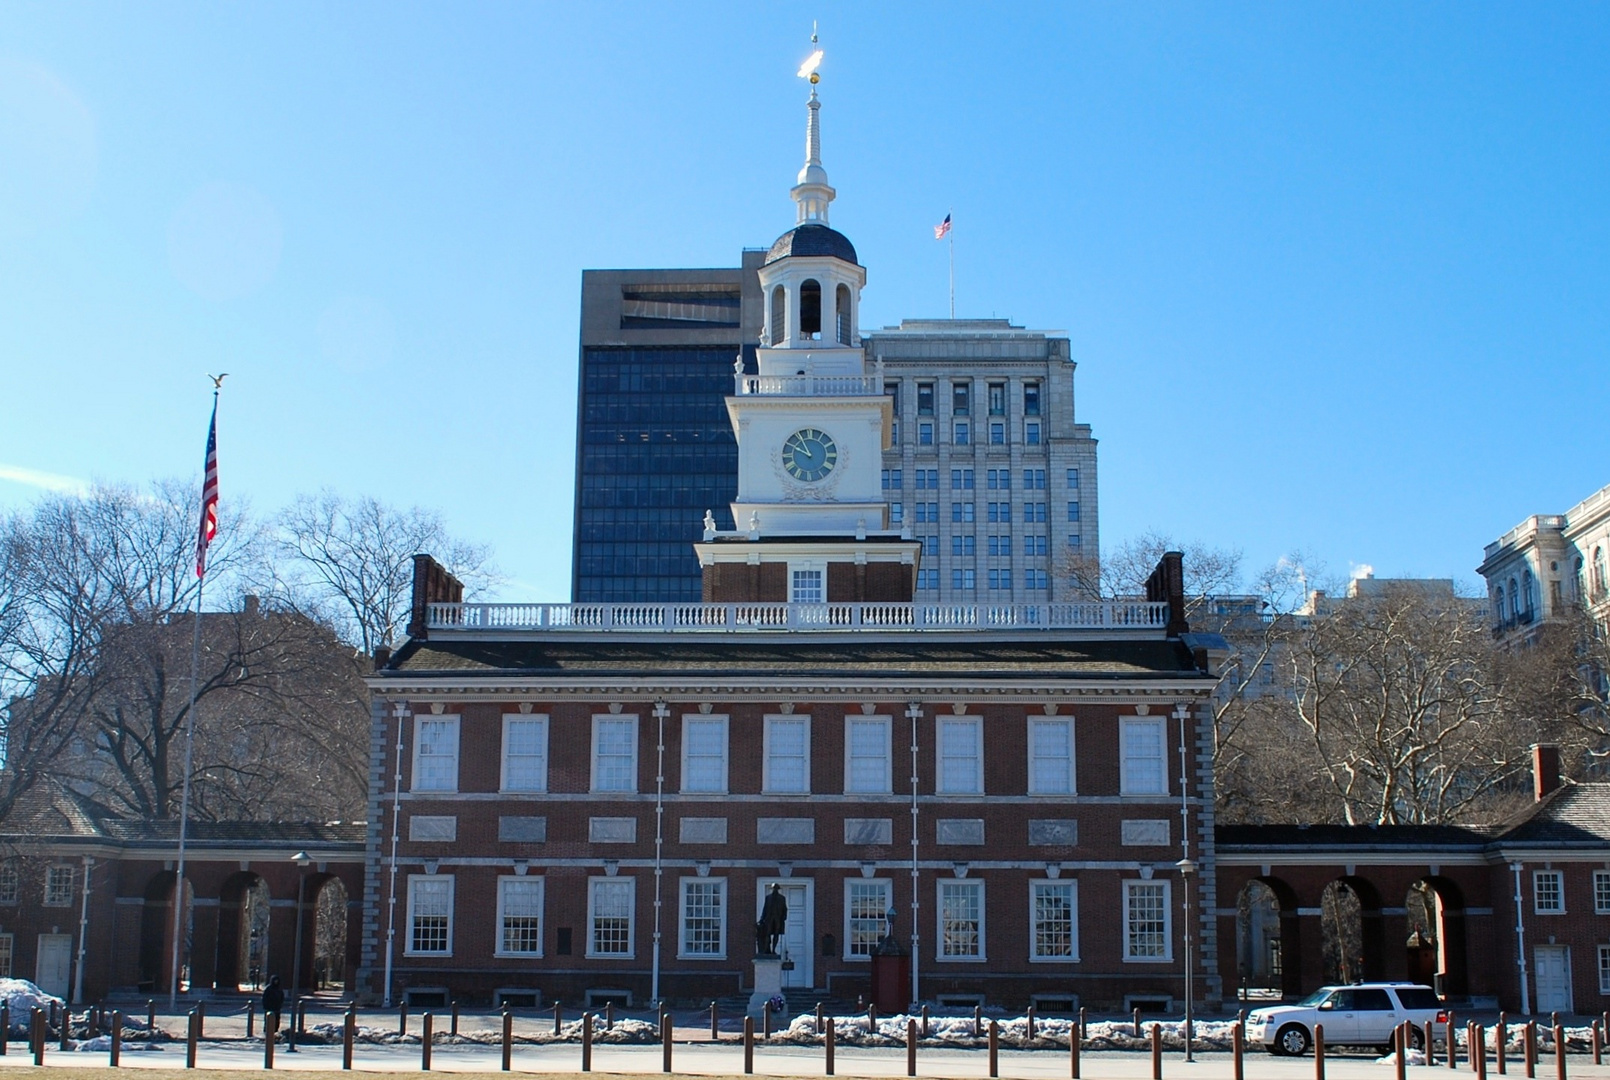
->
277 491 497 653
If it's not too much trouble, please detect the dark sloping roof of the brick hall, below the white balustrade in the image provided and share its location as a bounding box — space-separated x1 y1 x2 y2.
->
380 634 1203 682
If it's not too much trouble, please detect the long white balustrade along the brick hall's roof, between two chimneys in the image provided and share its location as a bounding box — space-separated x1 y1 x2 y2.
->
427 600 1169 634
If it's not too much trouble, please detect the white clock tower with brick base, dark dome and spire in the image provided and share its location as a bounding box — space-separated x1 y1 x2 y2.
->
694 64 919 602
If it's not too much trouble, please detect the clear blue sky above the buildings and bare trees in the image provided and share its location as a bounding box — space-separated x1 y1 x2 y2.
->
0 0 1610 600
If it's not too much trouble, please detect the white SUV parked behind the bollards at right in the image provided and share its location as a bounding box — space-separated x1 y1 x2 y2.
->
1246 982 1447 1054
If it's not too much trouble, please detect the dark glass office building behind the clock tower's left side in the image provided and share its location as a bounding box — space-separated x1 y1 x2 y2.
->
570 251 765 604
